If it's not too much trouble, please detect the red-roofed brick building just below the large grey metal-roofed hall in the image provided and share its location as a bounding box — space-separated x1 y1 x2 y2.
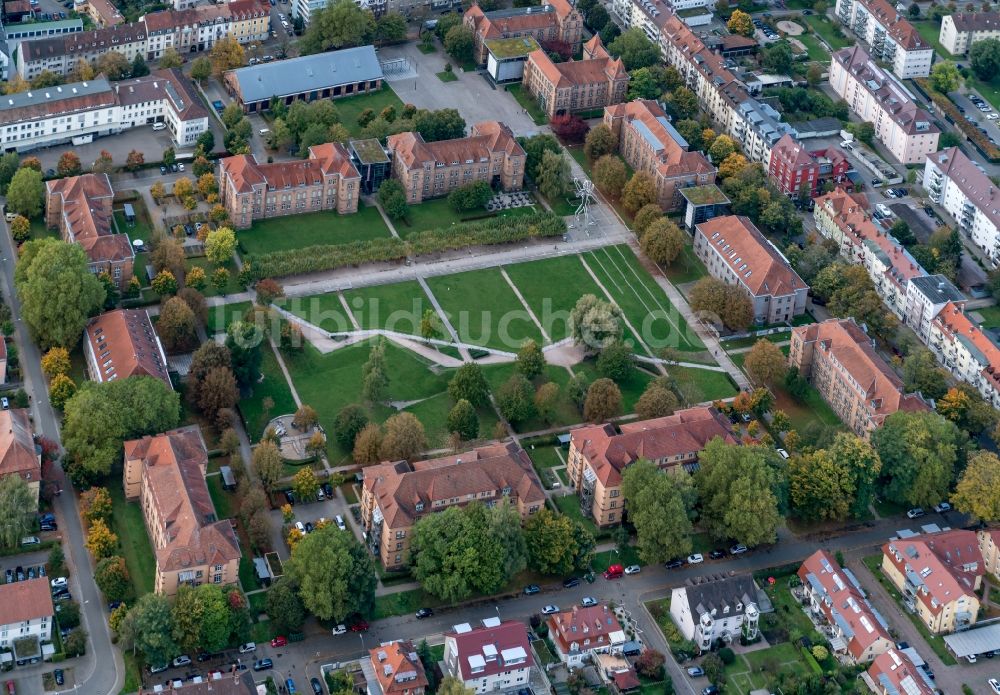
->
218 142 361 230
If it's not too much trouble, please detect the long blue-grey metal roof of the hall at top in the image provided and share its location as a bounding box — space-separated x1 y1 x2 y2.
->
233 46 382 103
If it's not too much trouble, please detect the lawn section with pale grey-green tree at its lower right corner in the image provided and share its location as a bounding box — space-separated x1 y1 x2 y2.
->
504 256 604 342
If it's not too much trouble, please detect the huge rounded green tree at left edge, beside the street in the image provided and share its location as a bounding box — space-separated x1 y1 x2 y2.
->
14 241 105 348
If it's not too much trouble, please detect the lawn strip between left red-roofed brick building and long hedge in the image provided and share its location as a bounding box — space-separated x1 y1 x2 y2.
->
236 204 390 255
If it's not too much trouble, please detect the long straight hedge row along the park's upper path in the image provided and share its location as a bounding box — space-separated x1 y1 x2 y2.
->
246 211 566 280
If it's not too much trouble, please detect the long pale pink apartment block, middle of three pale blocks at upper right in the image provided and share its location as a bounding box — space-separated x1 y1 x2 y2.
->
830 46 941 164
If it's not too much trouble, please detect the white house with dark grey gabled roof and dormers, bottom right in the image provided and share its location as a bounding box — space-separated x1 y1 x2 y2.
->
670 574 760 652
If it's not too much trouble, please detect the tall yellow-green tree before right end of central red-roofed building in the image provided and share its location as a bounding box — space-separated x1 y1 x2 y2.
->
622 459 693 564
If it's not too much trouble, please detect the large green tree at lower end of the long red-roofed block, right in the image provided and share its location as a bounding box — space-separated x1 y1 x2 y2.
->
871 410 966 507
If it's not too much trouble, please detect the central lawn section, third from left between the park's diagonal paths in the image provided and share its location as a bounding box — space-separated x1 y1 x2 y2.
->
427 268 542 352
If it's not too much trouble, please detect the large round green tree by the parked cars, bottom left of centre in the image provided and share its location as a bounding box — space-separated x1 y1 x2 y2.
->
285 528 376 622
